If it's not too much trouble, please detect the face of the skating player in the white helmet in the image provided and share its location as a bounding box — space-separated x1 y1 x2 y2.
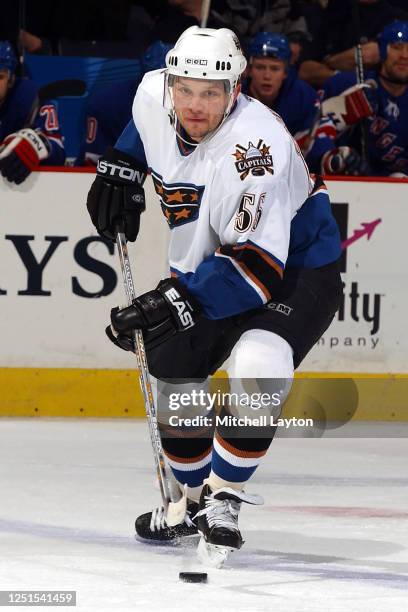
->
173 77 229 142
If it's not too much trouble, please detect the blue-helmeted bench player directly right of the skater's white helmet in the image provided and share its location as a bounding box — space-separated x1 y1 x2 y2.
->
242 32 320 157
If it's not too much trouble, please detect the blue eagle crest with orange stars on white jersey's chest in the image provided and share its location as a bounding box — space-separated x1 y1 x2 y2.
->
152 170 204 229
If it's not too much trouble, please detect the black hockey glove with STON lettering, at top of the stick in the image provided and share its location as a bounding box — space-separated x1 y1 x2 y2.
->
86 147 146 242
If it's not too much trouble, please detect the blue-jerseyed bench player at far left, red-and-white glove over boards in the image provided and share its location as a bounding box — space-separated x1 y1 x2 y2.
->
0 41 65 185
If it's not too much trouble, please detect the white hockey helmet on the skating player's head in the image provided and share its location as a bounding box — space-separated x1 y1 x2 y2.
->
166 26 247 122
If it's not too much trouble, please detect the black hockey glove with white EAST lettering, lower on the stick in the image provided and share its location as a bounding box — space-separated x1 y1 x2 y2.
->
106 278 200 351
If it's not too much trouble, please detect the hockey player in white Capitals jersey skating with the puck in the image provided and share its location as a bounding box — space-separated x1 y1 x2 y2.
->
87 26 342 564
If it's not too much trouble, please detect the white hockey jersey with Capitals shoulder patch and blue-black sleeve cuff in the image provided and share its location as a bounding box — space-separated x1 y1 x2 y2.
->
117 71 339 318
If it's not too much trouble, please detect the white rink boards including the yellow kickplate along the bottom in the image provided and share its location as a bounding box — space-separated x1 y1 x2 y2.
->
0 172 408 420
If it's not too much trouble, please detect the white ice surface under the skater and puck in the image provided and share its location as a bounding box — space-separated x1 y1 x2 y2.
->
0 419 408 612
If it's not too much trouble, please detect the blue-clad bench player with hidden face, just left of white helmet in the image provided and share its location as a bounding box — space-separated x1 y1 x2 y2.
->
75 40 172 166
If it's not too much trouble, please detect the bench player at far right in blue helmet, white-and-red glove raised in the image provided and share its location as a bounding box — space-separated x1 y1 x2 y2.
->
322 21 408 177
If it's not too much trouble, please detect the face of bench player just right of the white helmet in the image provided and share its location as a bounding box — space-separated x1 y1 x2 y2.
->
249 57 286 104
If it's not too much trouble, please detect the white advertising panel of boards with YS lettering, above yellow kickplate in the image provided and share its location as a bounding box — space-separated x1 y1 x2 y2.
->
0 171 408 373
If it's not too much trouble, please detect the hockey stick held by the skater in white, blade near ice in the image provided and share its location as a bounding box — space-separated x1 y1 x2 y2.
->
116 227 187 526
